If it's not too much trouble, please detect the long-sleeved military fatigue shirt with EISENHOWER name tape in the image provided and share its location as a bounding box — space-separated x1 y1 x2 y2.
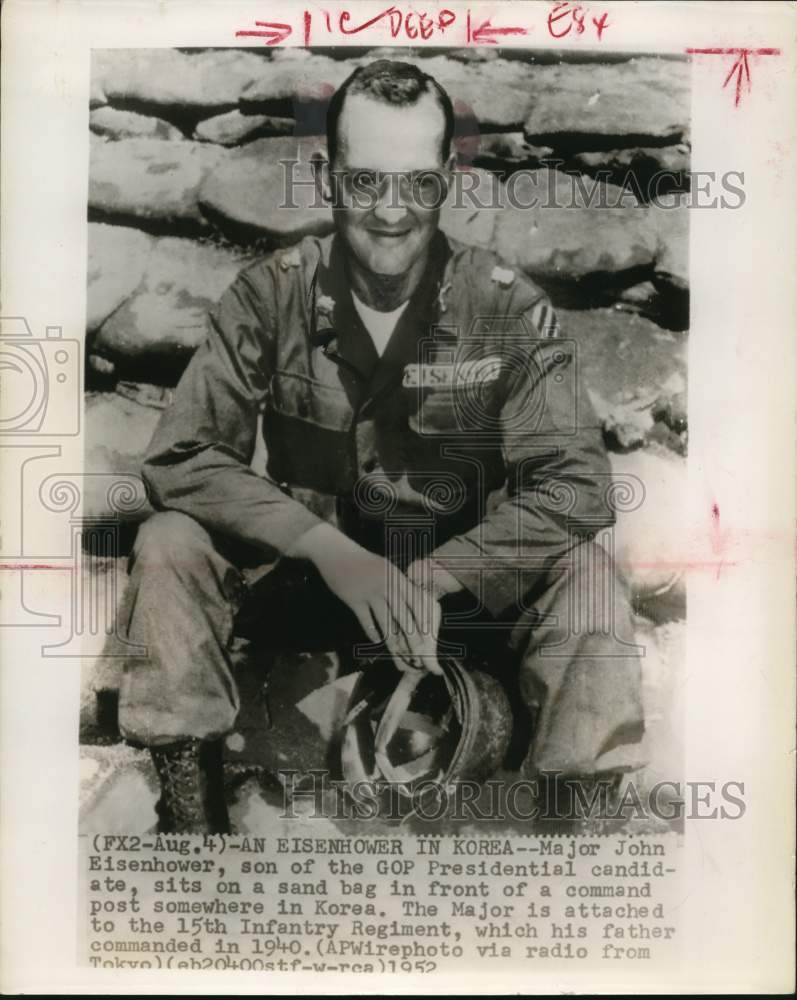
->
143 232 613 616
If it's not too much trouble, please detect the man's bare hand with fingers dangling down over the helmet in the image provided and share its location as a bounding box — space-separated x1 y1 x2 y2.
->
287 524 440 673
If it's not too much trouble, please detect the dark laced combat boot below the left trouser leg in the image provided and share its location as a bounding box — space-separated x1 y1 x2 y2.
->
150 739 230 833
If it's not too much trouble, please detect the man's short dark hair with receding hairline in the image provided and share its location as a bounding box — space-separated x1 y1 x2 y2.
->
327 59 454 163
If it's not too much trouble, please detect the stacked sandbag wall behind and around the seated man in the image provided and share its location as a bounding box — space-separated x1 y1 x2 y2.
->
81 49 689 830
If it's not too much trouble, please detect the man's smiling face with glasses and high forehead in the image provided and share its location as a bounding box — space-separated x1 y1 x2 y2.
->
332 94 446 275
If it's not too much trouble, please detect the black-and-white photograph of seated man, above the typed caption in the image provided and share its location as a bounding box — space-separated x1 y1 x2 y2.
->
81 49 690 833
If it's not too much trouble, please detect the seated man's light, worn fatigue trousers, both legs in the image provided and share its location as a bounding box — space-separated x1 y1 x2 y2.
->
119 511 644 776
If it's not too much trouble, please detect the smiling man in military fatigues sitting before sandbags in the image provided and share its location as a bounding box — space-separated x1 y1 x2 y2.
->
120 60 642 832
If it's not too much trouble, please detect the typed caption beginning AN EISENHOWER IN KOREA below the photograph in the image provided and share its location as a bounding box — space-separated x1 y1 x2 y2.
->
81 834 680 974
